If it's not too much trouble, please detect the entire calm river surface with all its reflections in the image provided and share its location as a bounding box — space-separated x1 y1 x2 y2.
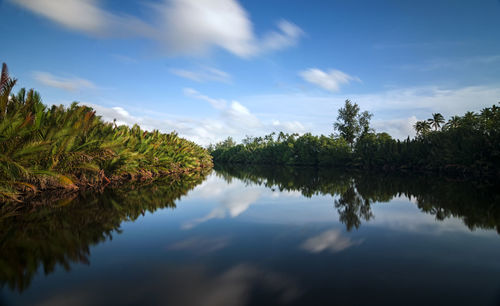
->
0 168 500 305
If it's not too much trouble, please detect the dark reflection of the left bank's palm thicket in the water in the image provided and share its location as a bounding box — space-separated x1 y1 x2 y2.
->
0 170 210 291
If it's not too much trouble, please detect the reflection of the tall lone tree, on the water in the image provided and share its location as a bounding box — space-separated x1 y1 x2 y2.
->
335 186 373 231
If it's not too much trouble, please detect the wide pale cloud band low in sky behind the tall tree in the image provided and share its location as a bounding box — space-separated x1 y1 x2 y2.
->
240 84 500 139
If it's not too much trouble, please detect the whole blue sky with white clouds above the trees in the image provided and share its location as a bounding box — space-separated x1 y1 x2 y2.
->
0 0 500 145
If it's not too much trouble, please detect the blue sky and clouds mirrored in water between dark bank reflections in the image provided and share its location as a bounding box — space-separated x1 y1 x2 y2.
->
0 175 500 305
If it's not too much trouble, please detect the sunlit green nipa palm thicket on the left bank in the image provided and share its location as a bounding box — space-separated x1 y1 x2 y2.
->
0 64 212 202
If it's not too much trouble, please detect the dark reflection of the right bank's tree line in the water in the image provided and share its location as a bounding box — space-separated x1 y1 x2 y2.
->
215 164 500 233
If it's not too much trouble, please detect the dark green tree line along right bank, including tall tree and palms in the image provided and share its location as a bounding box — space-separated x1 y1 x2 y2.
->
209 100 500 178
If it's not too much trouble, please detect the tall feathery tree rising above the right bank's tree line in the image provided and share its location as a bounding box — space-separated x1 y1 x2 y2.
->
333 99 373 147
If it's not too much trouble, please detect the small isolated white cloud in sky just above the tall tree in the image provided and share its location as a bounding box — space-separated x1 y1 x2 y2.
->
299 68 360 92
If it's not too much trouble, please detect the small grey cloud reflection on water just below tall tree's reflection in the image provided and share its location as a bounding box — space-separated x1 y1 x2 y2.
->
301 230 362 253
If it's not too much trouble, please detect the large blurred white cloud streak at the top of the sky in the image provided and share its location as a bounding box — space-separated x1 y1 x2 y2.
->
11 0 303 57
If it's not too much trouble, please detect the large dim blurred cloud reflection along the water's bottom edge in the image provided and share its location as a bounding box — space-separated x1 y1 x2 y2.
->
37 264 301 306
